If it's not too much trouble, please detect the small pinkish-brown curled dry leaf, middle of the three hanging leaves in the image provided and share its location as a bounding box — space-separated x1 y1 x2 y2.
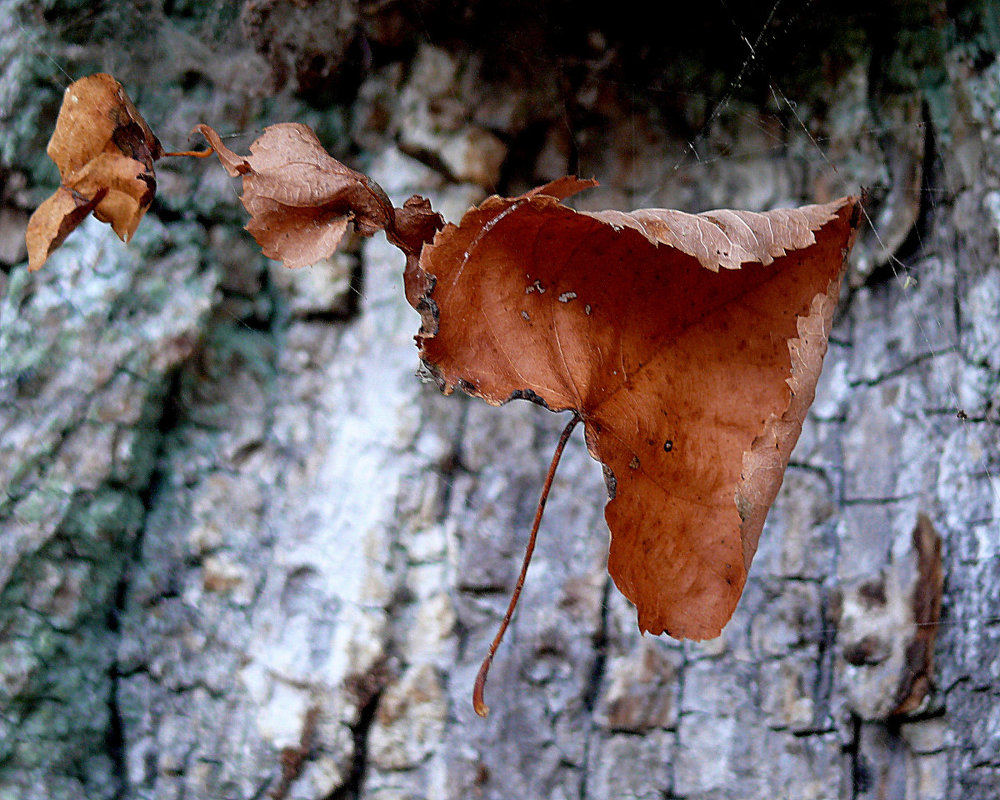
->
195 122 394 267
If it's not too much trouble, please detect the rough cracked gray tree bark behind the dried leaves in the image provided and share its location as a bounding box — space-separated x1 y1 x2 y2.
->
0 0 1000 800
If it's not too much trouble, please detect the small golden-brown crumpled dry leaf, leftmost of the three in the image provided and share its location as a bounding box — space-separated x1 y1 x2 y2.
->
25 73 163 270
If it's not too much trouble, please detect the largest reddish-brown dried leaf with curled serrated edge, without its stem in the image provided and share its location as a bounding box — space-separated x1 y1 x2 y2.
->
407 179 860 639
